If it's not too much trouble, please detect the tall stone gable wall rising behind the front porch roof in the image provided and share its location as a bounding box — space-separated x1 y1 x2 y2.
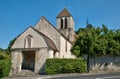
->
35 17 60 50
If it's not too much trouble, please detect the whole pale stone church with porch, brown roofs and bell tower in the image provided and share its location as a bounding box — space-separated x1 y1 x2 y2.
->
11 8 75 74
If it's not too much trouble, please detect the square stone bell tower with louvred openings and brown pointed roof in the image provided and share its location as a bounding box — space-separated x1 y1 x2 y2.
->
56 8 74 42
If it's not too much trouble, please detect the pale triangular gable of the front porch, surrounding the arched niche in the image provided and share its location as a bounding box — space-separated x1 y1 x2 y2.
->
12 27 48 49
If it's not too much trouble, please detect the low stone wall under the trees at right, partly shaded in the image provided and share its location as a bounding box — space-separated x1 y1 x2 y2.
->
89 55 120 72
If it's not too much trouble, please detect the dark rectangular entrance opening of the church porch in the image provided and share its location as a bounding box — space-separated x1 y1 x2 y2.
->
22 51 35 71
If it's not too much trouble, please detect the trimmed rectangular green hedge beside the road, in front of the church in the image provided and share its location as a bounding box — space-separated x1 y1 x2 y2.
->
45 58 87 74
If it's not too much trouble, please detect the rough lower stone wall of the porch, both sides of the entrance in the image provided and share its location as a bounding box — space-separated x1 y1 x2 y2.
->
11 48 49 75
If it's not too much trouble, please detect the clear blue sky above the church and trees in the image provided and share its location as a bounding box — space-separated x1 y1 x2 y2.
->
0 0 120 49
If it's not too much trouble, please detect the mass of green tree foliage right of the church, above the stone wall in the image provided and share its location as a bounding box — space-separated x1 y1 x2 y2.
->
71 25 120 57
